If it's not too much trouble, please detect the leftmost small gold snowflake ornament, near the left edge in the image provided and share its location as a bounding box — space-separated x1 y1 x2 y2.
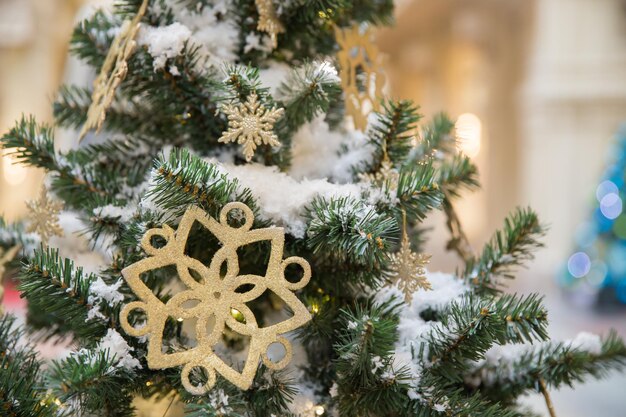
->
26 186 63 246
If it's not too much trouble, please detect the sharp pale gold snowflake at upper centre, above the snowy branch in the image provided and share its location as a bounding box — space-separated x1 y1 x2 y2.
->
218 93 284 162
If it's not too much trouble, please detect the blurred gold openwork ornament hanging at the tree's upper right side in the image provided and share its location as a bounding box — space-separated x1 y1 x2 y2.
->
335 24 385 131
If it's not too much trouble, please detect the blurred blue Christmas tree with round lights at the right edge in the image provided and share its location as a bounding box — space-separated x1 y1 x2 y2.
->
561 125 626 307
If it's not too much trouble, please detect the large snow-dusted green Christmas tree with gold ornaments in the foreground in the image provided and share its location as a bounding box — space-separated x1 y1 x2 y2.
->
0 0 626 417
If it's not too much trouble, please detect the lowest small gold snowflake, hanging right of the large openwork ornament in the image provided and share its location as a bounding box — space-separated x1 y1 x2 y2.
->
390 212 432 304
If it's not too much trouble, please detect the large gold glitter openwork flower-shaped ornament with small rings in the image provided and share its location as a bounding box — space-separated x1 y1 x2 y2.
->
120 203 311 395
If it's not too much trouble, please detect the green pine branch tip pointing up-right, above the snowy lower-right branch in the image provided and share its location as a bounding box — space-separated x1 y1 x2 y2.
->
461 209 545 294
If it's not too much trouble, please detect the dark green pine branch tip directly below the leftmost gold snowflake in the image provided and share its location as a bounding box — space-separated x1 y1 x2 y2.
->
19 248 107 342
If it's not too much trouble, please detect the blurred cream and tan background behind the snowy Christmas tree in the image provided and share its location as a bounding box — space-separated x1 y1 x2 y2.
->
0 0 626 417
